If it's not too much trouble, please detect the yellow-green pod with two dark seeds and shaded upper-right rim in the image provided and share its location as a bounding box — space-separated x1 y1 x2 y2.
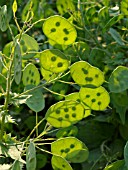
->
40 49 69 73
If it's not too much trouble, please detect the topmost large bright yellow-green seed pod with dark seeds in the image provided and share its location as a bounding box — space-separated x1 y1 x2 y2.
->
43 15 77 45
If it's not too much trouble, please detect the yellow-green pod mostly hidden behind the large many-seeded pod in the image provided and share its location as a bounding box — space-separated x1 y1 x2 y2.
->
65 92 91 118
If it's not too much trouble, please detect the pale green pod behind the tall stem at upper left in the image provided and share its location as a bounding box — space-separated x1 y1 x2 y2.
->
16 34 39 59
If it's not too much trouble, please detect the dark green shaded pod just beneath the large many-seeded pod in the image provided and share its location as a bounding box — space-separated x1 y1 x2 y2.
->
56 126 78 138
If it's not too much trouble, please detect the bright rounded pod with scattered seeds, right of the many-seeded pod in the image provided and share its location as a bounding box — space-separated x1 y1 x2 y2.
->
80 86 110 110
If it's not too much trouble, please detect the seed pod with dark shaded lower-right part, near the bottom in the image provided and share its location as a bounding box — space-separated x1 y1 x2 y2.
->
51 137 89 163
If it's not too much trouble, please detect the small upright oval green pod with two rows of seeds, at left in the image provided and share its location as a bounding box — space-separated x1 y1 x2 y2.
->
23 63 40 86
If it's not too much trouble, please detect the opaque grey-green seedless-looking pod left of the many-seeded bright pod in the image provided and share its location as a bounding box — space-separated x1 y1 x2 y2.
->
25 85 45 112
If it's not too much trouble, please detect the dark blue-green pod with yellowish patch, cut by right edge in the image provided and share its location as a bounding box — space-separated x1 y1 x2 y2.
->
109 66 128 93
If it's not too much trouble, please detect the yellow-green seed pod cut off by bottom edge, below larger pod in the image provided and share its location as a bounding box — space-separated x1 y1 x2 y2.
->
51 155 73 170
